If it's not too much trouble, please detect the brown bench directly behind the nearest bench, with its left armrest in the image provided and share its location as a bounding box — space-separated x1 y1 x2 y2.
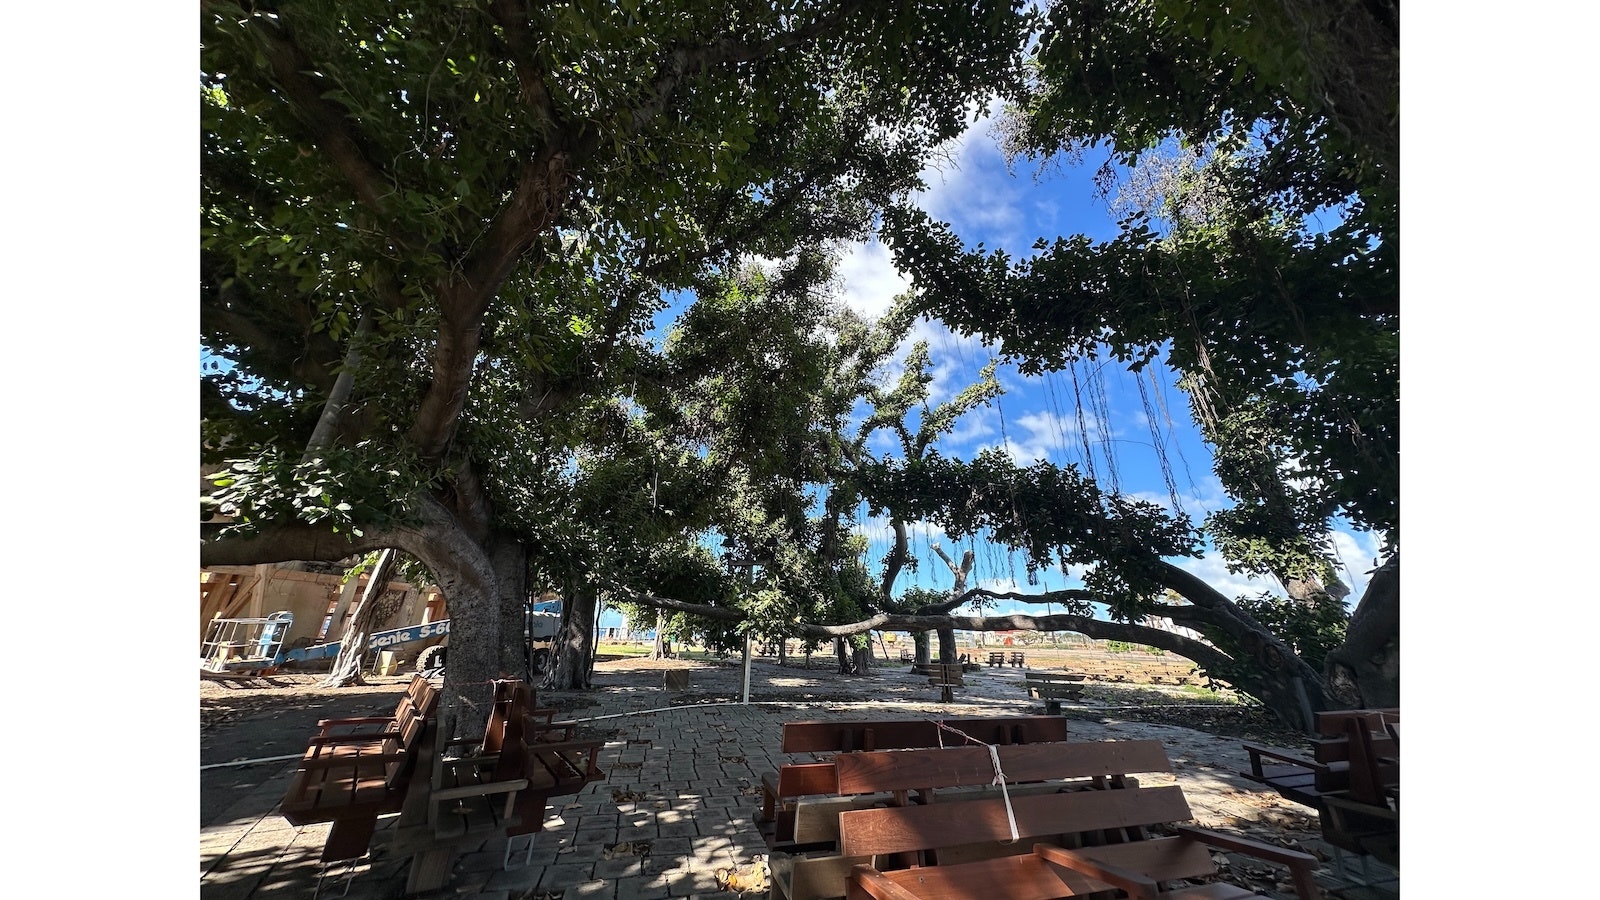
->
755 716 1067 847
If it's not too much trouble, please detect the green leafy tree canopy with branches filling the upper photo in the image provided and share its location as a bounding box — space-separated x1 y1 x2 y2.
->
200 0 1398 730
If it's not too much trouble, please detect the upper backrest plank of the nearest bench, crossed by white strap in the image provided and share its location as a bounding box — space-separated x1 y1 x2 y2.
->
832 740 1173 794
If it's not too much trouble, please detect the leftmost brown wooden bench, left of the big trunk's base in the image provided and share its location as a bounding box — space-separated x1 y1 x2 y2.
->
278 676 438 890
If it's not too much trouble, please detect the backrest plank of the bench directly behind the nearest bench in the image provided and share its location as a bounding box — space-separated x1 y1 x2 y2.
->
781 716 1067 753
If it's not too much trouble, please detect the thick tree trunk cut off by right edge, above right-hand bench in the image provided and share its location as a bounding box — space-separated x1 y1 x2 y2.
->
1325 552 1400 708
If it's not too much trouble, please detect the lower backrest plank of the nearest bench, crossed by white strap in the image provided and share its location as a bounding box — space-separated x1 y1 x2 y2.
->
838 785 1192 857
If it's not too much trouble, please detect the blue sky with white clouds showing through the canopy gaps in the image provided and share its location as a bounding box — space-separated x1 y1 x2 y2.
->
812 99 1381 612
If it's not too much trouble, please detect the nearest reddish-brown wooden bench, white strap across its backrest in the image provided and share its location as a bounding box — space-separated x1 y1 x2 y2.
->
838 741 1320 900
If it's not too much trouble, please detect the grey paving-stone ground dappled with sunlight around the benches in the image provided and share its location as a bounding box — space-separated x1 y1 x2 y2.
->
200 661 1398 900
